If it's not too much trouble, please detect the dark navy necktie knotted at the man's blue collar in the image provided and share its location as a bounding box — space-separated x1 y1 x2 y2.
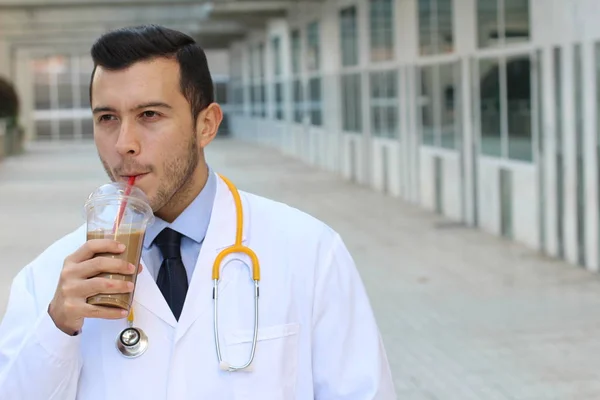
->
154 228 188 320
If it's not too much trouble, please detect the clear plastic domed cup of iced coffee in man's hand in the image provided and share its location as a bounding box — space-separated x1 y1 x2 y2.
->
84 182 154 311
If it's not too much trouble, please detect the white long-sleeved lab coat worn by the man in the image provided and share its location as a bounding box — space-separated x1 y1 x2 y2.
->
0 175 396 400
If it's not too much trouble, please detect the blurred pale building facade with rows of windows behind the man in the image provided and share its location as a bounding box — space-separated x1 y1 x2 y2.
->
0 0 600 270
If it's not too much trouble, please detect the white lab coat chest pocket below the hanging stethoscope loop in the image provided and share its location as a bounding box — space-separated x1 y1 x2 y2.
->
223 323 300 400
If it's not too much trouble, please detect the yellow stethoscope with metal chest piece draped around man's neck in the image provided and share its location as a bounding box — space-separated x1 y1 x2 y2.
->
116 175 260 372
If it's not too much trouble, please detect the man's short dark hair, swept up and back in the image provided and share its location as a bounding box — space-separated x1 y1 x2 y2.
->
90 25 214 120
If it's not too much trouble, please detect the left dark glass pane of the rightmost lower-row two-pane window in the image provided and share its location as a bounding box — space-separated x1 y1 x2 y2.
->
479 59 502 157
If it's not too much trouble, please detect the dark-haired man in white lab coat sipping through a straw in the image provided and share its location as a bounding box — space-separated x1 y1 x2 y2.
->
0 26 395 400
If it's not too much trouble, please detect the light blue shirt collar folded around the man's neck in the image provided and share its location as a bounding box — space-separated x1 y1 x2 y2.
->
144 167 217 249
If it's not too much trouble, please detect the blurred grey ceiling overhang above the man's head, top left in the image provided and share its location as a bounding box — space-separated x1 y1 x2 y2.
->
0 0 310 53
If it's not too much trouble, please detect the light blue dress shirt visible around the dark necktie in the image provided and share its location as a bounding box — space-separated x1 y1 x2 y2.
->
142 168 217 282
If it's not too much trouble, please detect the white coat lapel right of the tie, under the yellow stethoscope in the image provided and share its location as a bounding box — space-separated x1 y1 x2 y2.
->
175 173 249 341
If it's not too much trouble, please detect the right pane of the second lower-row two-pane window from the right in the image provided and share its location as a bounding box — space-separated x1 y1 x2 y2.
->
438 63 458 149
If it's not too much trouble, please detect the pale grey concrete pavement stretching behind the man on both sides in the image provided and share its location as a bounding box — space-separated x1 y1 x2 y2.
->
0 140 600 400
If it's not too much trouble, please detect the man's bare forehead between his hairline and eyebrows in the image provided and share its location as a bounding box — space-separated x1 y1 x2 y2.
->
92 58 183 108
